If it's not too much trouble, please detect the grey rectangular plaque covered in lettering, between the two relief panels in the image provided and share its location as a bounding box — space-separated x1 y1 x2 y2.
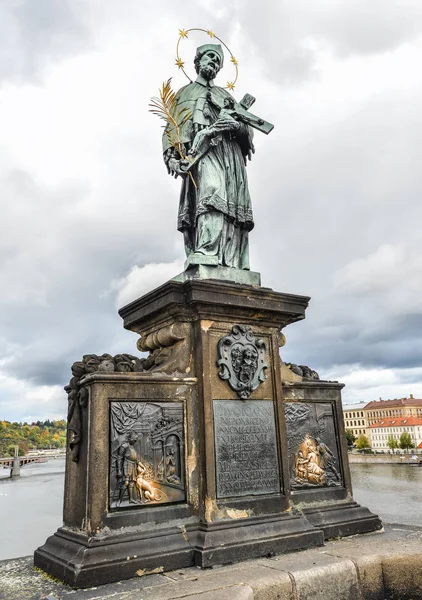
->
213 400 280 498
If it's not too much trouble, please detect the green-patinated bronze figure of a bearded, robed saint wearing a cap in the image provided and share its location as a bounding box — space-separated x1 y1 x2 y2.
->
163 44 254 269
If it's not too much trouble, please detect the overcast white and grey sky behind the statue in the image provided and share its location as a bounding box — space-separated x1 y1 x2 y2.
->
0 0 422 421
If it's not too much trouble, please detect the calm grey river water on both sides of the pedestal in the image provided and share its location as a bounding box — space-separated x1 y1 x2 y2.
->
0 458 422 560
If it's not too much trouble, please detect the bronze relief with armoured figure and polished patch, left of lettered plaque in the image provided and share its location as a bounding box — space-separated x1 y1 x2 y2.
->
110 400 185 510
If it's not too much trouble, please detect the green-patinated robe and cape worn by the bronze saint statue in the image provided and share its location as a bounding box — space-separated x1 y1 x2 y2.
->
163 82 254 269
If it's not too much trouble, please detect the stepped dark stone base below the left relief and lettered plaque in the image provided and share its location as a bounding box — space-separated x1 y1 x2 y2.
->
34 513 324 588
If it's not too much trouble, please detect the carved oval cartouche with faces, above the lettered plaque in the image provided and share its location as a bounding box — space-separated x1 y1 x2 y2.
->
217 325 268 400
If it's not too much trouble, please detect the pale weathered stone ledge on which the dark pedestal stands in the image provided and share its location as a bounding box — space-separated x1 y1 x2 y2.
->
0 526 422 600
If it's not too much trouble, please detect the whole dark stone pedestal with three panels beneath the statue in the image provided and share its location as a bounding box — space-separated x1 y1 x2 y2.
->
35 279 380 587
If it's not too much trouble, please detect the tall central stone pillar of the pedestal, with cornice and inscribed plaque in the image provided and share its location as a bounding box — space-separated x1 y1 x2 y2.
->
120 280 323 567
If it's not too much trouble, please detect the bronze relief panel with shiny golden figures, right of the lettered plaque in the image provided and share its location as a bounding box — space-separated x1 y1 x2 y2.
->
284 402 342 490
